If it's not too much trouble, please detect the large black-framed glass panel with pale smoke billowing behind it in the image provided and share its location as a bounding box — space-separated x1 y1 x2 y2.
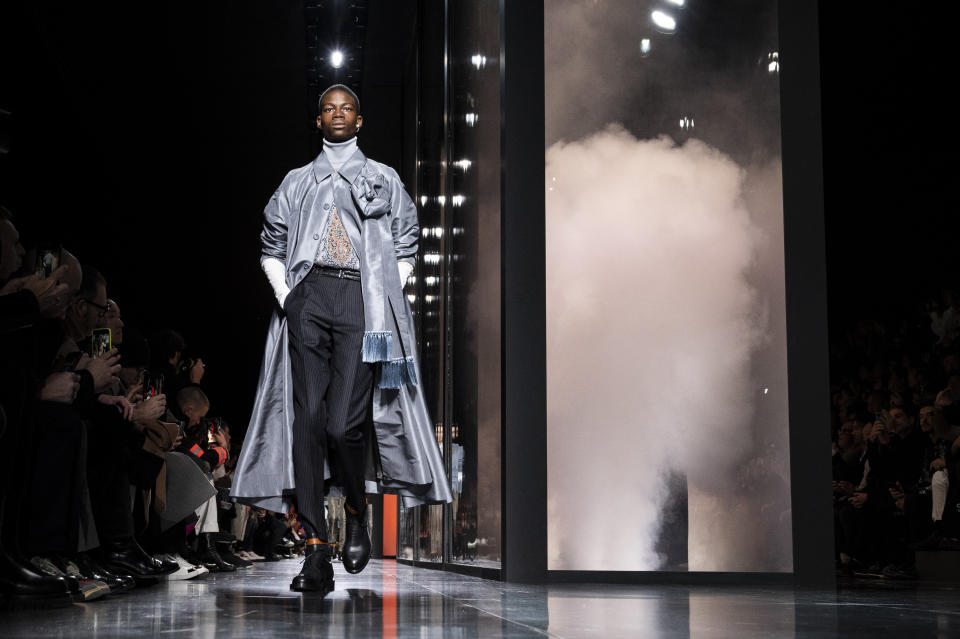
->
544 0 792 572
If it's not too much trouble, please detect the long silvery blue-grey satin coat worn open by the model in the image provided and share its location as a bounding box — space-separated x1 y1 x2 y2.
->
230 150 452 512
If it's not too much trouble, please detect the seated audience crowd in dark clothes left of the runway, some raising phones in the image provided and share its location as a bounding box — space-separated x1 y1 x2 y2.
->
0 207 308 601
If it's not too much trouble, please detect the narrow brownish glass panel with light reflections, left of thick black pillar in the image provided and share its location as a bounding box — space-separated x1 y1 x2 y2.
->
445 0 501 568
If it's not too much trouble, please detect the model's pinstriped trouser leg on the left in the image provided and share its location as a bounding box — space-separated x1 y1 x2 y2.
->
285 269 337 541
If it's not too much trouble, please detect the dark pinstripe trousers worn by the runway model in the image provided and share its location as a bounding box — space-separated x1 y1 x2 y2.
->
283 267 373 540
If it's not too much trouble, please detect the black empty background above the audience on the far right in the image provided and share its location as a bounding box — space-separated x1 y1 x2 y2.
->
819 2 960 328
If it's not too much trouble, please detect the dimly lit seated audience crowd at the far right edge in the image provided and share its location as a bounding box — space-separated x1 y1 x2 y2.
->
831 292 960 578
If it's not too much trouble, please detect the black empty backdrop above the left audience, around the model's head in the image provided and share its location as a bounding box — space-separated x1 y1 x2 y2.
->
0 0 415 430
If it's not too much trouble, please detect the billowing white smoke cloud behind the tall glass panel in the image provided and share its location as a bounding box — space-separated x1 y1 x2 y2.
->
546 126 790 570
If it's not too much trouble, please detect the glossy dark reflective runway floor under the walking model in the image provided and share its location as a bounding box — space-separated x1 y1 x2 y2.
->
0 560 960 639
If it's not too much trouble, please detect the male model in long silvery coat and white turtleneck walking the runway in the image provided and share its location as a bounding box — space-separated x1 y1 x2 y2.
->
231 84 452 592
